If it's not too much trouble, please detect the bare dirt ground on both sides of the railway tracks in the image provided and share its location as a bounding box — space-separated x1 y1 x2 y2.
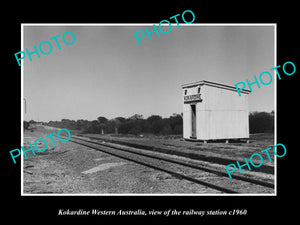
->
22 127 273 194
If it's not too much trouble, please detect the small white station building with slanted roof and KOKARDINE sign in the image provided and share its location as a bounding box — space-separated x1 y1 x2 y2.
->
182 80 250 142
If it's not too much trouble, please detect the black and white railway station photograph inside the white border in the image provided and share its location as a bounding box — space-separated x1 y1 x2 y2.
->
20 23 276 195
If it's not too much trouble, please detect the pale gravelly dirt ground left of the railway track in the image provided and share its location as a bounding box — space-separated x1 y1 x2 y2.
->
23 125 224 194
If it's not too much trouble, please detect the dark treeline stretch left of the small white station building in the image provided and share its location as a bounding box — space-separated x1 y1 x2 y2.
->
44 114 183 135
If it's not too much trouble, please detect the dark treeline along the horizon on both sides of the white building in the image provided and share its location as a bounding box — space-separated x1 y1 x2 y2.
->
29 111 274 135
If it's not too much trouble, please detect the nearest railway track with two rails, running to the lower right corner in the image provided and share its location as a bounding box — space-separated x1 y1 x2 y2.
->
70 136 274 194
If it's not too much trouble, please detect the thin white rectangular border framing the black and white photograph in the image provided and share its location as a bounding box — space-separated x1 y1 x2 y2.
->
21 23 277 196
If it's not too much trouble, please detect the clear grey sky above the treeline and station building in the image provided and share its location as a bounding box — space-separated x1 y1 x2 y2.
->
22 23 276 122
